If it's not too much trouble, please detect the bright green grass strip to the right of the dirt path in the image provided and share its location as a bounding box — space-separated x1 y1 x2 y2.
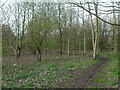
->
90 53 118 88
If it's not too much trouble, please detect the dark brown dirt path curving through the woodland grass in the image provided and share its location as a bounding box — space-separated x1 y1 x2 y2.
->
57 56 109 88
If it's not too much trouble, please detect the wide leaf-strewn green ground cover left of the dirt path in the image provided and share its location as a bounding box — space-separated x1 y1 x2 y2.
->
2 56 98 88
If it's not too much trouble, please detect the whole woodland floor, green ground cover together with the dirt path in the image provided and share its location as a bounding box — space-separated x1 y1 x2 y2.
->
3 54 118 88
